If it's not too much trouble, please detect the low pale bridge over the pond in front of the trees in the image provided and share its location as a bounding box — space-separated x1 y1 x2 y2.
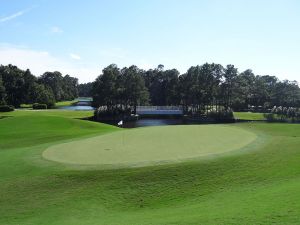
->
136 106 183 115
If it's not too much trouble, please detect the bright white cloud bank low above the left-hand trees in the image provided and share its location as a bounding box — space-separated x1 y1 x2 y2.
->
0 43 101 83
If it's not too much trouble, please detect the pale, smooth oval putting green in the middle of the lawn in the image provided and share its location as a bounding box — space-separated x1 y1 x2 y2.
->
43 125 256 166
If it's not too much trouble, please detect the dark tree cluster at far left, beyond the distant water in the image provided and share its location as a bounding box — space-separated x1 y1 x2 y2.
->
0 65 78 108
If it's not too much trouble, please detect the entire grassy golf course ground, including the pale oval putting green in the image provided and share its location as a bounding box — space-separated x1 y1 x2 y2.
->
0 110 300 225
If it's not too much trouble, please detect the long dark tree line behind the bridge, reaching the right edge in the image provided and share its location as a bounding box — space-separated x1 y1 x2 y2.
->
89 63 300 115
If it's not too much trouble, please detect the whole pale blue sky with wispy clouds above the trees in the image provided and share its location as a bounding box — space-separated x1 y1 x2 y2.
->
0 0 300 82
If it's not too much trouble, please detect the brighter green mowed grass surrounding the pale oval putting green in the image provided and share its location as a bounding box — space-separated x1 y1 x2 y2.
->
0 112 300 225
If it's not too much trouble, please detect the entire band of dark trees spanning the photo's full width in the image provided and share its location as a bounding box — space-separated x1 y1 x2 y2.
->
0 63 300 118
